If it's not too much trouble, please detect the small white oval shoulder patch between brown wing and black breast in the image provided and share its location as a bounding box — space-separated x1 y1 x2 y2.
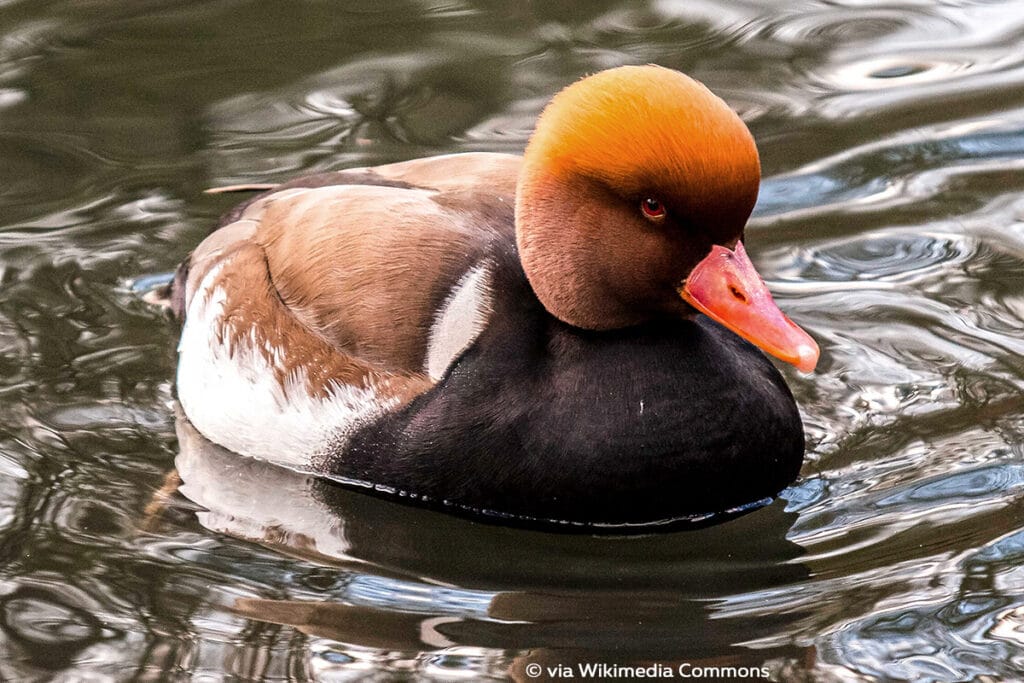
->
426 263 494 381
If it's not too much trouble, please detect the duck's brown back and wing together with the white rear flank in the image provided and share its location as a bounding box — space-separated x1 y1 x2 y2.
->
177 155 518 467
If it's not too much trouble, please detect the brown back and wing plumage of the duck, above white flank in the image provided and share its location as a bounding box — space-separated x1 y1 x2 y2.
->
176 154 520 393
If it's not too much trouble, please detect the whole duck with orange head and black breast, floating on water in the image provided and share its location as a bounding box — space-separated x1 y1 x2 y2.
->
171 65 819 529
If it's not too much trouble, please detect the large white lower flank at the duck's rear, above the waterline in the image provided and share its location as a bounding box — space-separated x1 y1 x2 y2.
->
177 263 396 470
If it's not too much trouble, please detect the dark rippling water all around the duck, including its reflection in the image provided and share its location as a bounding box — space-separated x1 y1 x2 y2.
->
0 0 1024 681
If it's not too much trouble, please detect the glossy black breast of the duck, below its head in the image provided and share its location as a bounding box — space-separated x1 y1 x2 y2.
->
323 253 804 524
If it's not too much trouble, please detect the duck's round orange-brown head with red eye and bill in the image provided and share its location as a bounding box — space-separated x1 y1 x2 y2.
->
516 66 817 369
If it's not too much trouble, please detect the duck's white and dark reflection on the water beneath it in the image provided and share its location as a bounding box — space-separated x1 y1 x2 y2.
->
176 409 807 675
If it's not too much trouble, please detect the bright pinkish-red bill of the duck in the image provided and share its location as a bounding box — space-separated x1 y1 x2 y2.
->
679 242 819 373
